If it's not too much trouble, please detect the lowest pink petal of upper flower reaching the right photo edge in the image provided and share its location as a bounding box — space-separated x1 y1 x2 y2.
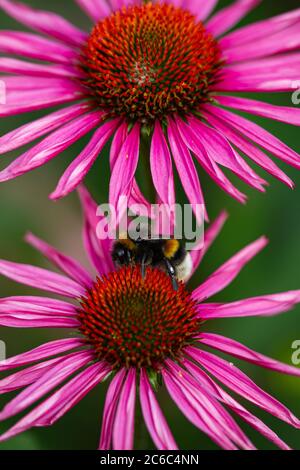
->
204 105 300 168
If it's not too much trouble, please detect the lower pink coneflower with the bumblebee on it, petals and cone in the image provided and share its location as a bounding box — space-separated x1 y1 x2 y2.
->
0 188 300 450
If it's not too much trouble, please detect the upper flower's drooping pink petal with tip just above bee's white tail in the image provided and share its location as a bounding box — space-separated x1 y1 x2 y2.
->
168 119 207 225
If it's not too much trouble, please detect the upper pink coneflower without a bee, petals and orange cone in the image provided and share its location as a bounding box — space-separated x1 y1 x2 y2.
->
0 0 300 212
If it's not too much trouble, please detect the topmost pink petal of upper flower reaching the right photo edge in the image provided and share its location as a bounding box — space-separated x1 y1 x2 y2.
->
220 8 300 49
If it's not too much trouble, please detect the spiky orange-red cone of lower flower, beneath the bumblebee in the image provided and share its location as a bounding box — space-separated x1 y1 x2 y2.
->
78 265 199 369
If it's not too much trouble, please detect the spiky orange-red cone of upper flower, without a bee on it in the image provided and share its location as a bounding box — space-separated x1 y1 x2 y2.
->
81 3 220 123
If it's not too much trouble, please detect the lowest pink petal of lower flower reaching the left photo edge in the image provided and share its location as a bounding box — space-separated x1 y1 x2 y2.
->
0 362 109 441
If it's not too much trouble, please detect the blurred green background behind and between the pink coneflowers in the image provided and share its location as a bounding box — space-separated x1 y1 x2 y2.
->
0 0 300 449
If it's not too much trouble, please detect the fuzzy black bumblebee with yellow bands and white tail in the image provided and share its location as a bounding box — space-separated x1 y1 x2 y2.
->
112 236 192 290
